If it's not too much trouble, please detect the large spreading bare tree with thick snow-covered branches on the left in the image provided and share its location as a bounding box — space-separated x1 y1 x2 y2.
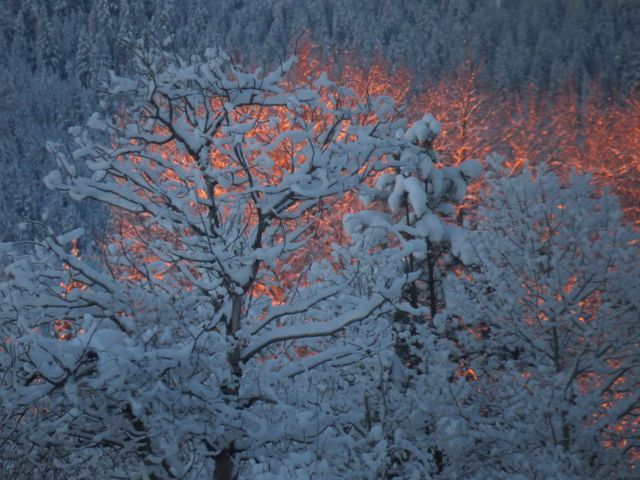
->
0 46 424 479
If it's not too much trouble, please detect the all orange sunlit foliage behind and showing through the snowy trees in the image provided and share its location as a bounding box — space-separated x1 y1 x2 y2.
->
91 42 640 462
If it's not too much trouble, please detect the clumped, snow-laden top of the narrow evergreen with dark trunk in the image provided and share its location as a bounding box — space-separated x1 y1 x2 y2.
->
352 114 482 318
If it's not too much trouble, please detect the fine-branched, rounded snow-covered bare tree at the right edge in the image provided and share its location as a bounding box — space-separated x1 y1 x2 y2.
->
441 165 640 478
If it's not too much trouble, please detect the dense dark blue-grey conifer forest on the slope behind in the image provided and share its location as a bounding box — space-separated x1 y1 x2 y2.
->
0 0 640 240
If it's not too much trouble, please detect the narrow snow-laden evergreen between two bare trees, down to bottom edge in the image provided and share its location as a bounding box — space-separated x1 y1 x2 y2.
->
298 114 482 479
